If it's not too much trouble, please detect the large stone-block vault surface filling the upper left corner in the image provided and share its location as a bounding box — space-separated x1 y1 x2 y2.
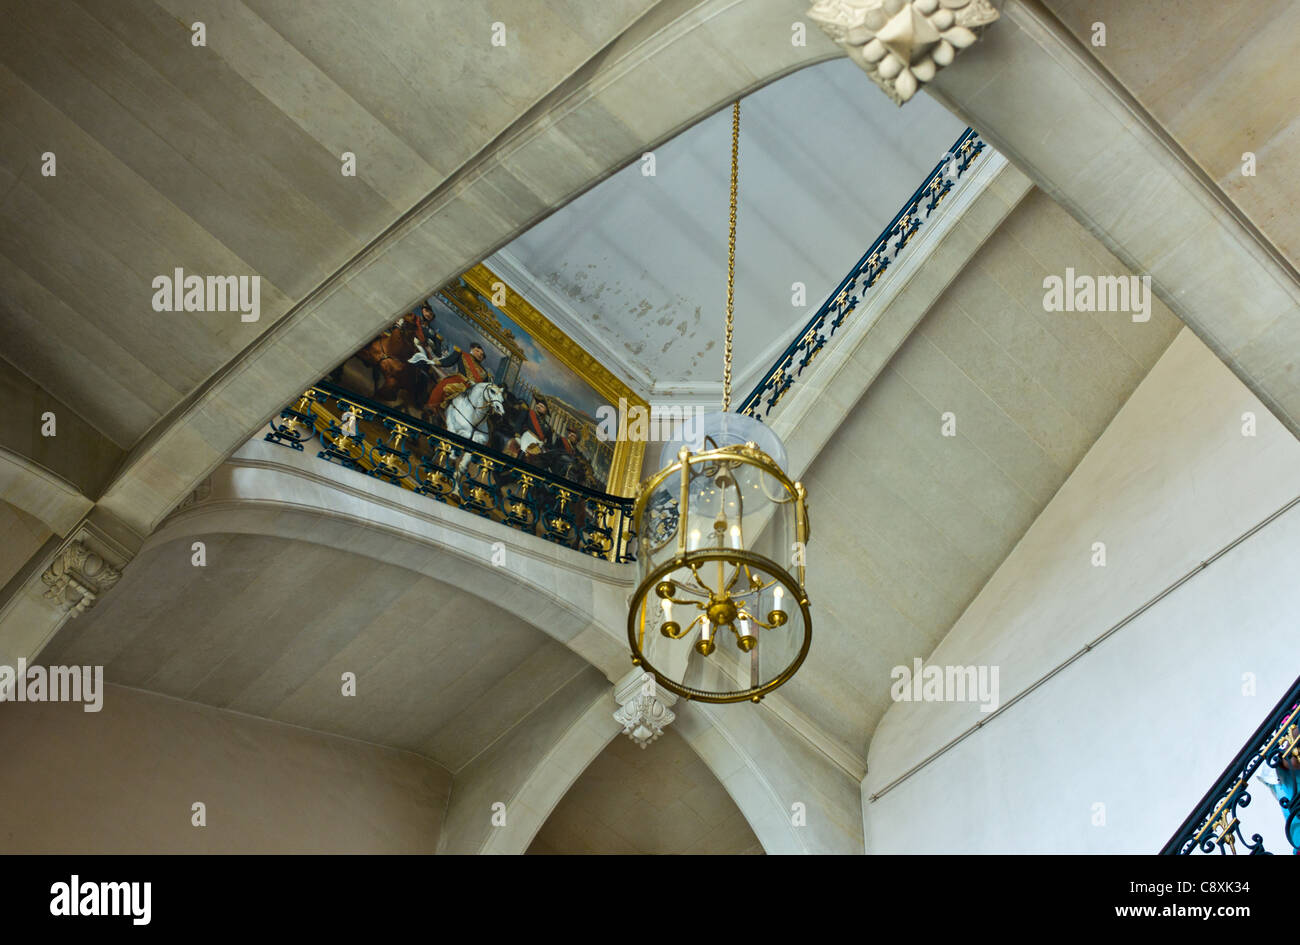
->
0 0 654 447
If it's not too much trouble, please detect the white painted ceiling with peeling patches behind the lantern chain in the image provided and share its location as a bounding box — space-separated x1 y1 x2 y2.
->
488 60 965 398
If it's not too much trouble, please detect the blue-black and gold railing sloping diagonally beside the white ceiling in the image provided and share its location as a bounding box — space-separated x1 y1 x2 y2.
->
737 129 987 422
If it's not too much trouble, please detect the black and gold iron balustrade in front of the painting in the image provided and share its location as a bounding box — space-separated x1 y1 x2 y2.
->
265 381 633 562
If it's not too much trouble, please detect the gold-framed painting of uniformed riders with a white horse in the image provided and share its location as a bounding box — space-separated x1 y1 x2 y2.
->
332 264 645 495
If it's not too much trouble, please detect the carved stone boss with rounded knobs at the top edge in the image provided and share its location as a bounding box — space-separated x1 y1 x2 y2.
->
809 0 998 105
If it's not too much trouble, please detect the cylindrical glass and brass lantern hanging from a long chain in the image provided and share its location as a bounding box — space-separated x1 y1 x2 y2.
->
628 101 813 702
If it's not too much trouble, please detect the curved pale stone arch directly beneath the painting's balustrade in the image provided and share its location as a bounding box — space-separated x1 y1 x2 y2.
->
152 441 631 679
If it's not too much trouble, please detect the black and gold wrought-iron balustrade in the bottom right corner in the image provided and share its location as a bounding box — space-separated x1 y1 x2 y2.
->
1161 679 1300 855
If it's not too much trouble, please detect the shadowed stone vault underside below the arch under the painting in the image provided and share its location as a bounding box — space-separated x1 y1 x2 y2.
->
42 536 586 772
